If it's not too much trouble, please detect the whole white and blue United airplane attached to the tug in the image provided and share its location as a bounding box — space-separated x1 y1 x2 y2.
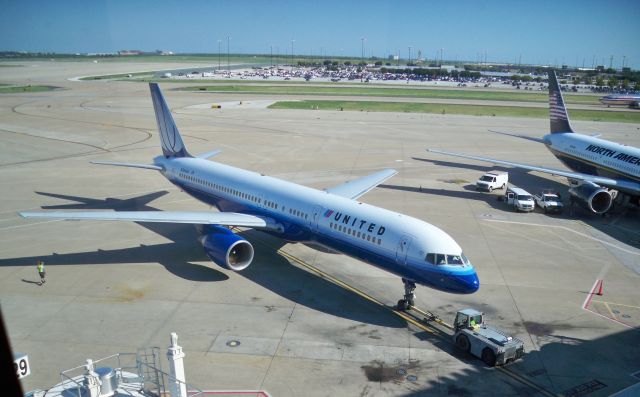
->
20 83 480 310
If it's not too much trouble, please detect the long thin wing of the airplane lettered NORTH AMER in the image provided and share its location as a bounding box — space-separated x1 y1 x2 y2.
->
427 149 640 192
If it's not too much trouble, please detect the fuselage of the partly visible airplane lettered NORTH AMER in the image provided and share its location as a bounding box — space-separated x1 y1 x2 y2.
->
543 133 640 194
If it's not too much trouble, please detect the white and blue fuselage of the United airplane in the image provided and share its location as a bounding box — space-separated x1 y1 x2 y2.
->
154 156 479 294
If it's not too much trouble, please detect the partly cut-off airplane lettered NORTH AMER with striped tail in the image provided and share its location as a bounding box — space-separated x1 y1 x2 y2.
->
427 71 640 214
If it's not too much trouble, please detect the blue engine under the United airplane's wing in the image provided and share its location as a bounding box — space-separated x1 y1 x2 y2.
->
200 226 253 272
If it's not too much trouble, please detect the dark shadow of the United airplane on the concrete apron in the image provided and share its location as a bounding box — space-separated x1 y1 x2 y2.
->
0 191 406 328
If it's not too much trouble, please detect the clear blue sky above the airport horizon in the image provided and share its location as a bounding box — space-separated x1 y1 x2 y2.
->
0 0 640 69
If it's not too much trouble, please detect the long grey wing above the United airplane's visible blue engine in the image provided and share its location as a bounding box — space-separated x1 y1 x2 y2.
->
20 211 273 229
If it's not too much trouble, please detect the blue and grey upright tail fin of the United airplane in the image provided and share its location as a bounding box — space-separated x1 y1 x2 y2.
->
149 83 193 157
